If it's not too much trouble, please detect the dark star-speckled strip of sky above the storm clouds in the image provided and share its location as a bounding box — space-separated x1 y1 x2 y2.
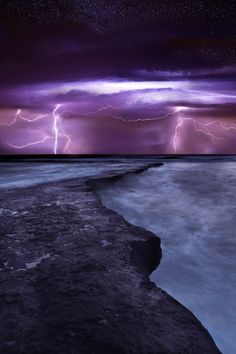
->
0 0 236 38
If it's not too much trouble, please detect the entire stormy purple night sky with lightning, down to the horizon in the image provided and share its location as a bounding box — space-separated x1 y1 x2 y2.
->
0 0 236 154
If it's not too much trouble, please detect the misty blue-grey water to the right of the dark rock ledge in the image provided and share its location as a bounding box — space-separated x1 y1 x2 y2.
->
99 161 236 354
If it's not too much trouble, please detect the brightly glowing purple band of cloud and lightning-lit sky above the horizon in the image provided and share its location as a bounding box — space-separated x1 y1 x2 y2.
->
0 74 236 154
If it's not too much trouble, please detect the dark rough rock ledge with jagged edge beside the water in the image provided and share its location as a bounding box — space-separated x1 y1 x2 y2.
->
0 164 219 354
